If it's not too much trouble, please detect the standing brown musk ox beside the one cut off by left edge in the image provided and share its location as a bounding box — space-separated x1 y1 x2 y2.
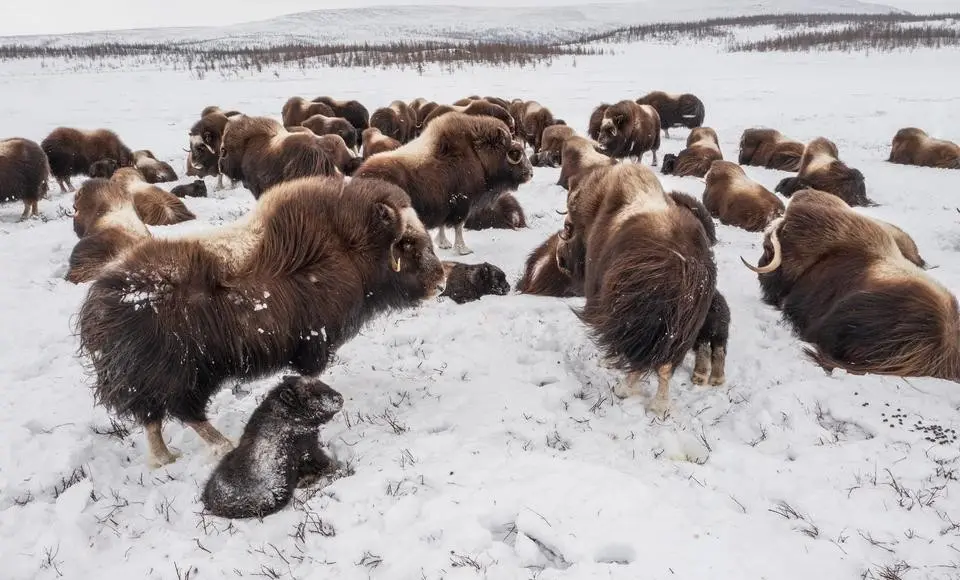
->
40 127 133 193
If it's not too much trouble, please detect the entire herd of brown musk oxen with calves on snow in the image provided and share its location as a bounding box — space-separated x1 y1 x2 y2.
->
0 91 960 517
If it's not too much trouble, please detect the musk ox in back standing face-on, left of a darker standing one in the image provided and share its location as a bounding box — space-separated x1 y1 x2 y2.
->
597 101 660 165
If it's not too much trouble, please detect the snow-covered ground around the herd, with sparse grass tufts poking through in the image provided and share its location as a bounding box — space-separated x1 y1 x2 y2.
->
0 34 960 580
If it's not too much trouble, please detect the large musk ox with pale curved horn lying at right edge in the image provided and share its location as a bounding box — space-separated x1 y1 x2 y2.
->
744 190 960 382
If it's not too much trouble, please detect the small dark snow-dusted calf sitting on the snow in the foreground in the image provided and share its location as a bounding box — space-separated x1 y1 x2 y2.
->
201 375 343 518
